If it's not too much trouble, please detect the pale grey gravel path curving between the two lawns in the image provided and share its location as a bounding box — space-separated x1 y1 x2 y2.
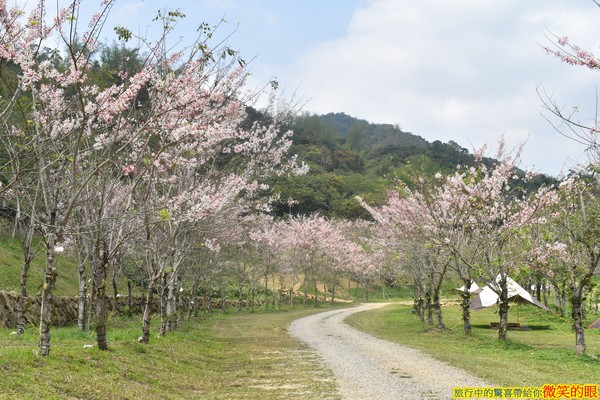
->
289 304 490 400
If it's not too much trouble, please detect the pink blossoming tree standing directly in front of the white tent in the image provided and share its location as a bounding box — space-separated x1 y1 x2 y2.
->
436 142 558 340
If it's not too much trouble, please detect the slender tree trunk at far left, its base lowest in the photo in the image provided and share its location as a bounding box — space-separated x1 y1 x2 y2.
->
39 239 58 356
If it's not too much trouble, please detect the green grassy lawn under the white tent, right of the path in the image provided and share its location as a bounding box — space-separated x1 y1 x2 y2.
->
346 305 600 386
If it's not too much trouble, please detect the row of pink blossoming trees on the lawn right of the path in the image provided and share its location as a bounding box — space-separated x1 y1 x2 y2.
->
358 142 558 340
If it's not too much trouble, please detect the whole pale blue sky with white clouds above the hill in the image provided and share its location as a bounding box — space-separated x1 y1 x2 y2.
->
9 0 600 175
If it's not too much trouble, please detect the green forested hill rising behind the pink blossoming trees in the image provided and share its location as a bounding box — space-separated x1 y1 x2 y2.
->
264 113 553 219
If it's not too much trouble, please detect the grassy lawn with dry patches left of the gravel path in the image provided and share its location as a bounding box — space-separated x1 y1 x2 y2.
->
0 308 337 399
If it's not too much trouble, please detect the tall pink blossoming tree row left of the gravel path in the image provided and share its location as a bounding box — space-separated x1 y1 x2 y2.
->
0 0 304 355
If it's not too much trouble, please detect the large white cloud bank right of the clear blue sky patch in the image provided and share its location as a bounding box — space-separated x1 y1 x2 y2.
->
276 0 600 174
